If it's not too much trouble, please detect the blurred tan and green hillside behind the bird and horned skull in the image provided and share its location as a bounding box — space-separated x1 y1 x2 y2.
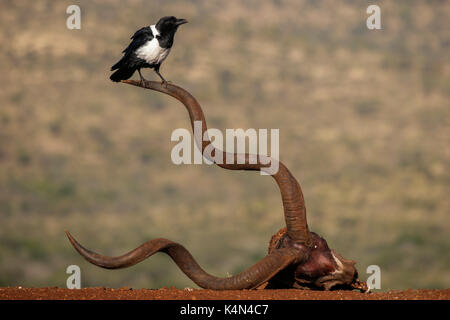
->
0 0 450 290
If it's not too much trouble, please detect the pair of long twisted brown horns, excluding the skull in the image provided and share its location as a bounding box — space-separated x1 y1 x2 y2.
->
66 80 312 290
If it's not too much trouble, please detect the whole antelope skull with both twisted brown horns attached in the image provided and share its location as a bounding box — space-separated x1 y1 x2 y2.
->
66 80 367 291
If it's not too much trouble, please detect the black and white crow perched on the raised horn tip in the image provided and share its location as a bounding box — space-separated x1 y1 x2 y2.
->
110 16 187 83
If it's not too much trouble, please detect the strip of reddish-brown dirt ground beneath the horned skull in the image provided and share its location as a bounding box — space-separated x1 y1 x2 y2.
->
0 287 450 300
